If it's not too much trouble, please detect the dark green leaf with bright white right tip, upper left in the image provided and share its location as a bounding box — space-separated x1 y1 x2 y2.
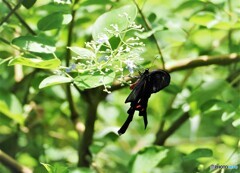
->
37 12 72 31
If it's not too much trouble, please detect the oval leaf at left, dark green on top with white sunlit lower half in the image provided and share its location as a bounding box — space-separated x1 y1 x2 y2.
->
12 36 56 54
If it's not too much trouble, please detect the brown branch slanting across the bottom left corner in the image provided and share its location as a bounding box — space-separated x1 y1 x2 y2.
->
0 150 33 173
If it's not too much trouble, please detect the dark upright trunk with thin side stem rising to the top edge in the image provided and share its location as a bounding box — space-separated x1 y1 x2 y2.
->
63 0 101 167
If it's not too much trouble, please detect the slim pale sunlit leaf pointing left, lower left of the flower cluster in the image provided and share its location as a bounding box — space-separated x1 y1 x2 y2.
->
39 75 72 89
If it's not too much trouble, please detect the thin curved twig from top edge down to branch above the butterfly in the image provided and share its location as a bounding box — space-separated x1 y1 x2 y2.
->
133 0 165 70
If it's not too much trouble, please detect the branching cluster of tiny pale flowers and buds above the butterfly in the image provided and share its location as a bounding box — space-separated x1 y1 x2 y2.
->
67 14 144 91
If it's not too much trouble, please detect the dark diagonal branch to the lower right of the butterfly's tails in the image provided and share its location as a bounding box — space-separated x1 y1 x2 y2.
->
154 112 190 145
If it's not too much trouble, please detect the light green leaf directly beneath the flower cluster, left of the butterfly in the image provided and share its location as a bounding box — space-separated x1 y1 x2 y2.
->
74 70 115 89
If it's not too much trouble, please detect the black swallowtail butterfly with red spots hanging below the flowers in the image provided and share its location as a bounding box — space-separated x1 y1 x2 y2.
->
118 69 171 135
